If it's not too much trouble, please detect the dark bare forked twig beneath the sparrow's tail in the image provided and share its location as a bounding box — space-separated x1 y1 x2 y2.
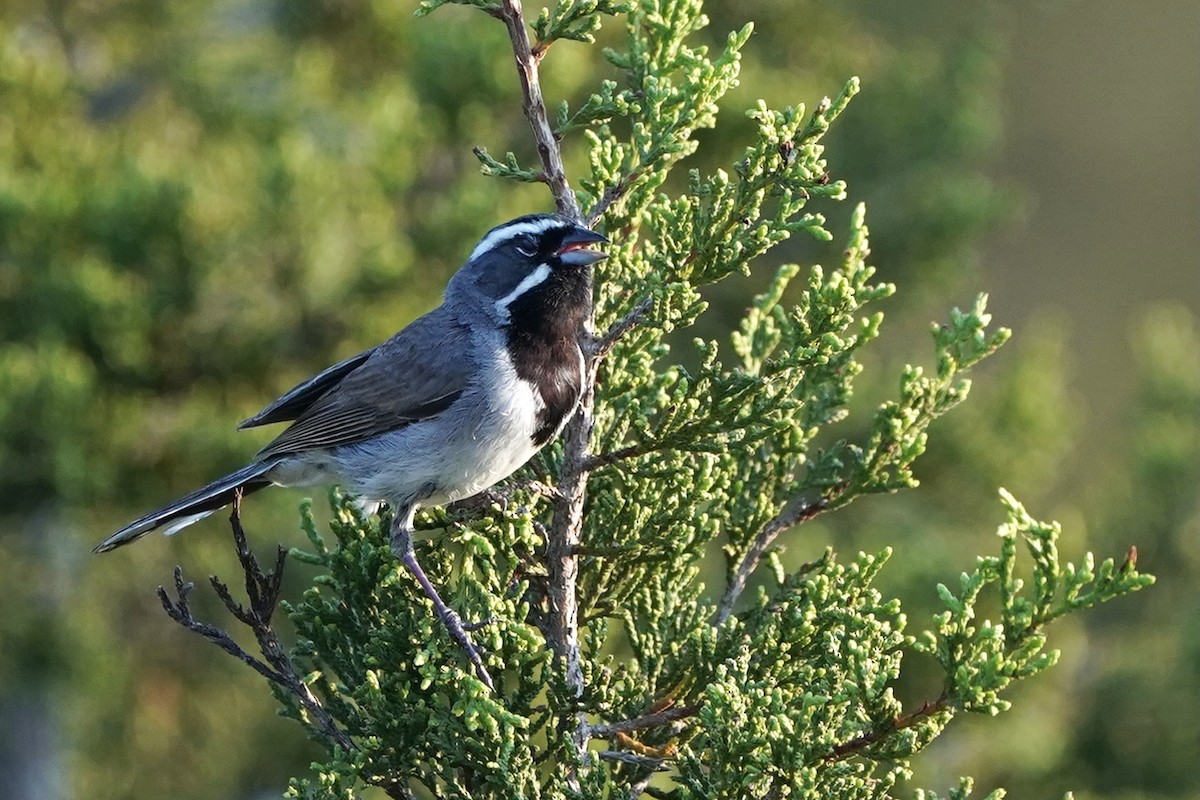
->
158 494 350 753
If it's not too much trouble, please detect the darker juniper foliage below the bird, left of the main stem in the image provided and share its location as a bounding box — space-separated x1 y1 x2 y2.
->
284 497 546 796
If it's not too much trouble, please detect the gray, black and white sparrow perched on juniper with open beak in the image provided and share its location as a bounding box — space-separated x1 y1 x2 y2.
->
96 215 607 686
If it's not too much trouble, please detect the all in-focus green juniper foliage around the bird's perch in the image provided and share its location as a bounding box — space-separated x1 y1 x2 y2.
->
189 0 1151 799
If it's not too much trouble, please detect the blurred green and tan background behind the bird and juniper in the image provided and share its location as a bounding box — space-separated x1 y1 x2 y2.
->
0 0 1200 800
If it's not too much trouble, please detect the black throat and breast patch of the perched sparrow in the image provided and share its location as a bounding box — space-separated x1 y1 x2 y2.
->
508 265 592 447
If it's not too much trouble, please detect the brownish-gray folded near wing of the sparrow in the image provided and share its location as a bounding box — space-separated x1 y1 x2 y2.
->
251 307 472 458
